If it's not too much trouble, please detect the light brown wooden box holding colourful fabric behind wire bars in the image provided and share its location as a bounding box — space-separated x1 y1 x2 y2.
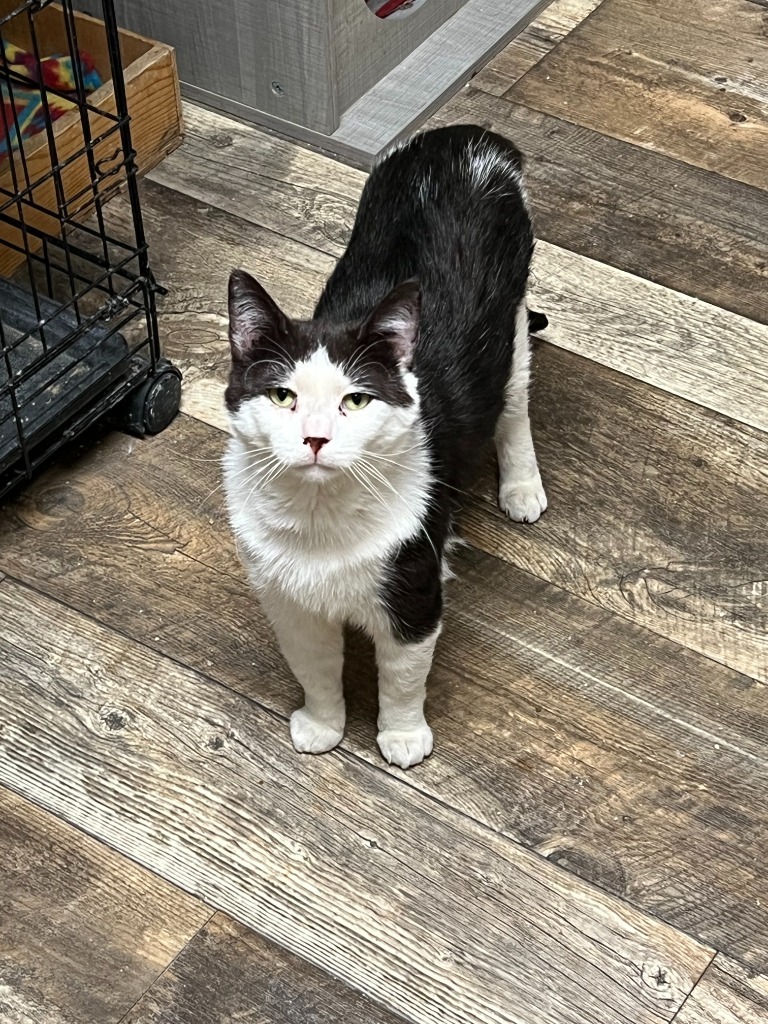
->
0 0 182 276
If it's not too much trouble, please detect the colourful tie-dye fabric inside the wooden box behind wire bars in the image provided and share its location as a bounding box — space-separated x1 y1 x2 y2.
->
0 42 101 160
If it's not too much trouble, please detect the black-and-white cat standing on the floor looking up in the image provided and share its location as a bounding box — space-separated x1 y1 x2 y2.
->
224 125 547 768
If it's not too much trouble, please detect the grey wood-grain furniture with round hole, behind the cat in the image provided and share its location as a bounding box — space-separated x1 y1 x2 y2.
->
85 0 550 163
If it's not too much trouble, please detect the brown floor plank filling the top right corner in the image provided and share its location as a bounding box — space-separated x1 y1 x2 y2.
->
510 0 768 188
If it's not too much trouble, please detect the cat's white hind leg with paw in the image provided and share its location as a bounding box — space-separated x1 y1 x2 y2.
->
496 300 547 522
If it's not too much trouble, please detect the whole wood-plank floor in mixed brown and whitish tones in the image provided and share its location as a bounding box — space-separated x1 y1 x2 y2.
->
0 0 768 1024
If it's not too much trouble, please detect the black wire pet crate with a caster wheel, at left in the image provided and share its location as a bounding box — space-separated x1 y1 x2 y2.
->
0 0 181 498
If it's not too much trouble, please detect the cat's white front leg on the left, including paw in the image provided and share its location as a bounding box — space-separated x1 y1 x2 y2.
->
261 597 346 754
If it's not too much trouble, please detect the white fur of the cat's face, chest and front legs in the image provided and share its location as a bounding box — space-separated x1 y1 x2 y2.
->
224 348 437 768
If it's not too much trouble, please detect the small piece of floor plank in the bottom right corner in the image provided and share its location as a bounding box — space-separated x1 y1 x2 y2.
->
675 953 768 1024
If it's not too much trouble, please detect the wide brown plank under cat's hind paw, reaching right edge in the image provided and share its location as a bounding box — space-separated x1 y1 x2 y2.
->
463 346 768 682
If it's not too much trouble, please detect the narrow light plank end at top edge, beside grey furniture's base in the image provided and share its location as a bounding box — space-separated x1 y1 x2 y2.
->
472 0 602 96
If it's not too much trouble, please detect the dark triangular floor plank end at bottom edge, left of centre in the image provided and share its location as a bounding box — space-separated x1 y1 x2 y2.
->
121 913 403 1024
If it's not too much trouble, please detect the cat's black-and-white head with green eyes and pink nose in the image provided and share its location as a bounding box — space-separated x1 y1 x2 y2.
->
226 270 420 480
